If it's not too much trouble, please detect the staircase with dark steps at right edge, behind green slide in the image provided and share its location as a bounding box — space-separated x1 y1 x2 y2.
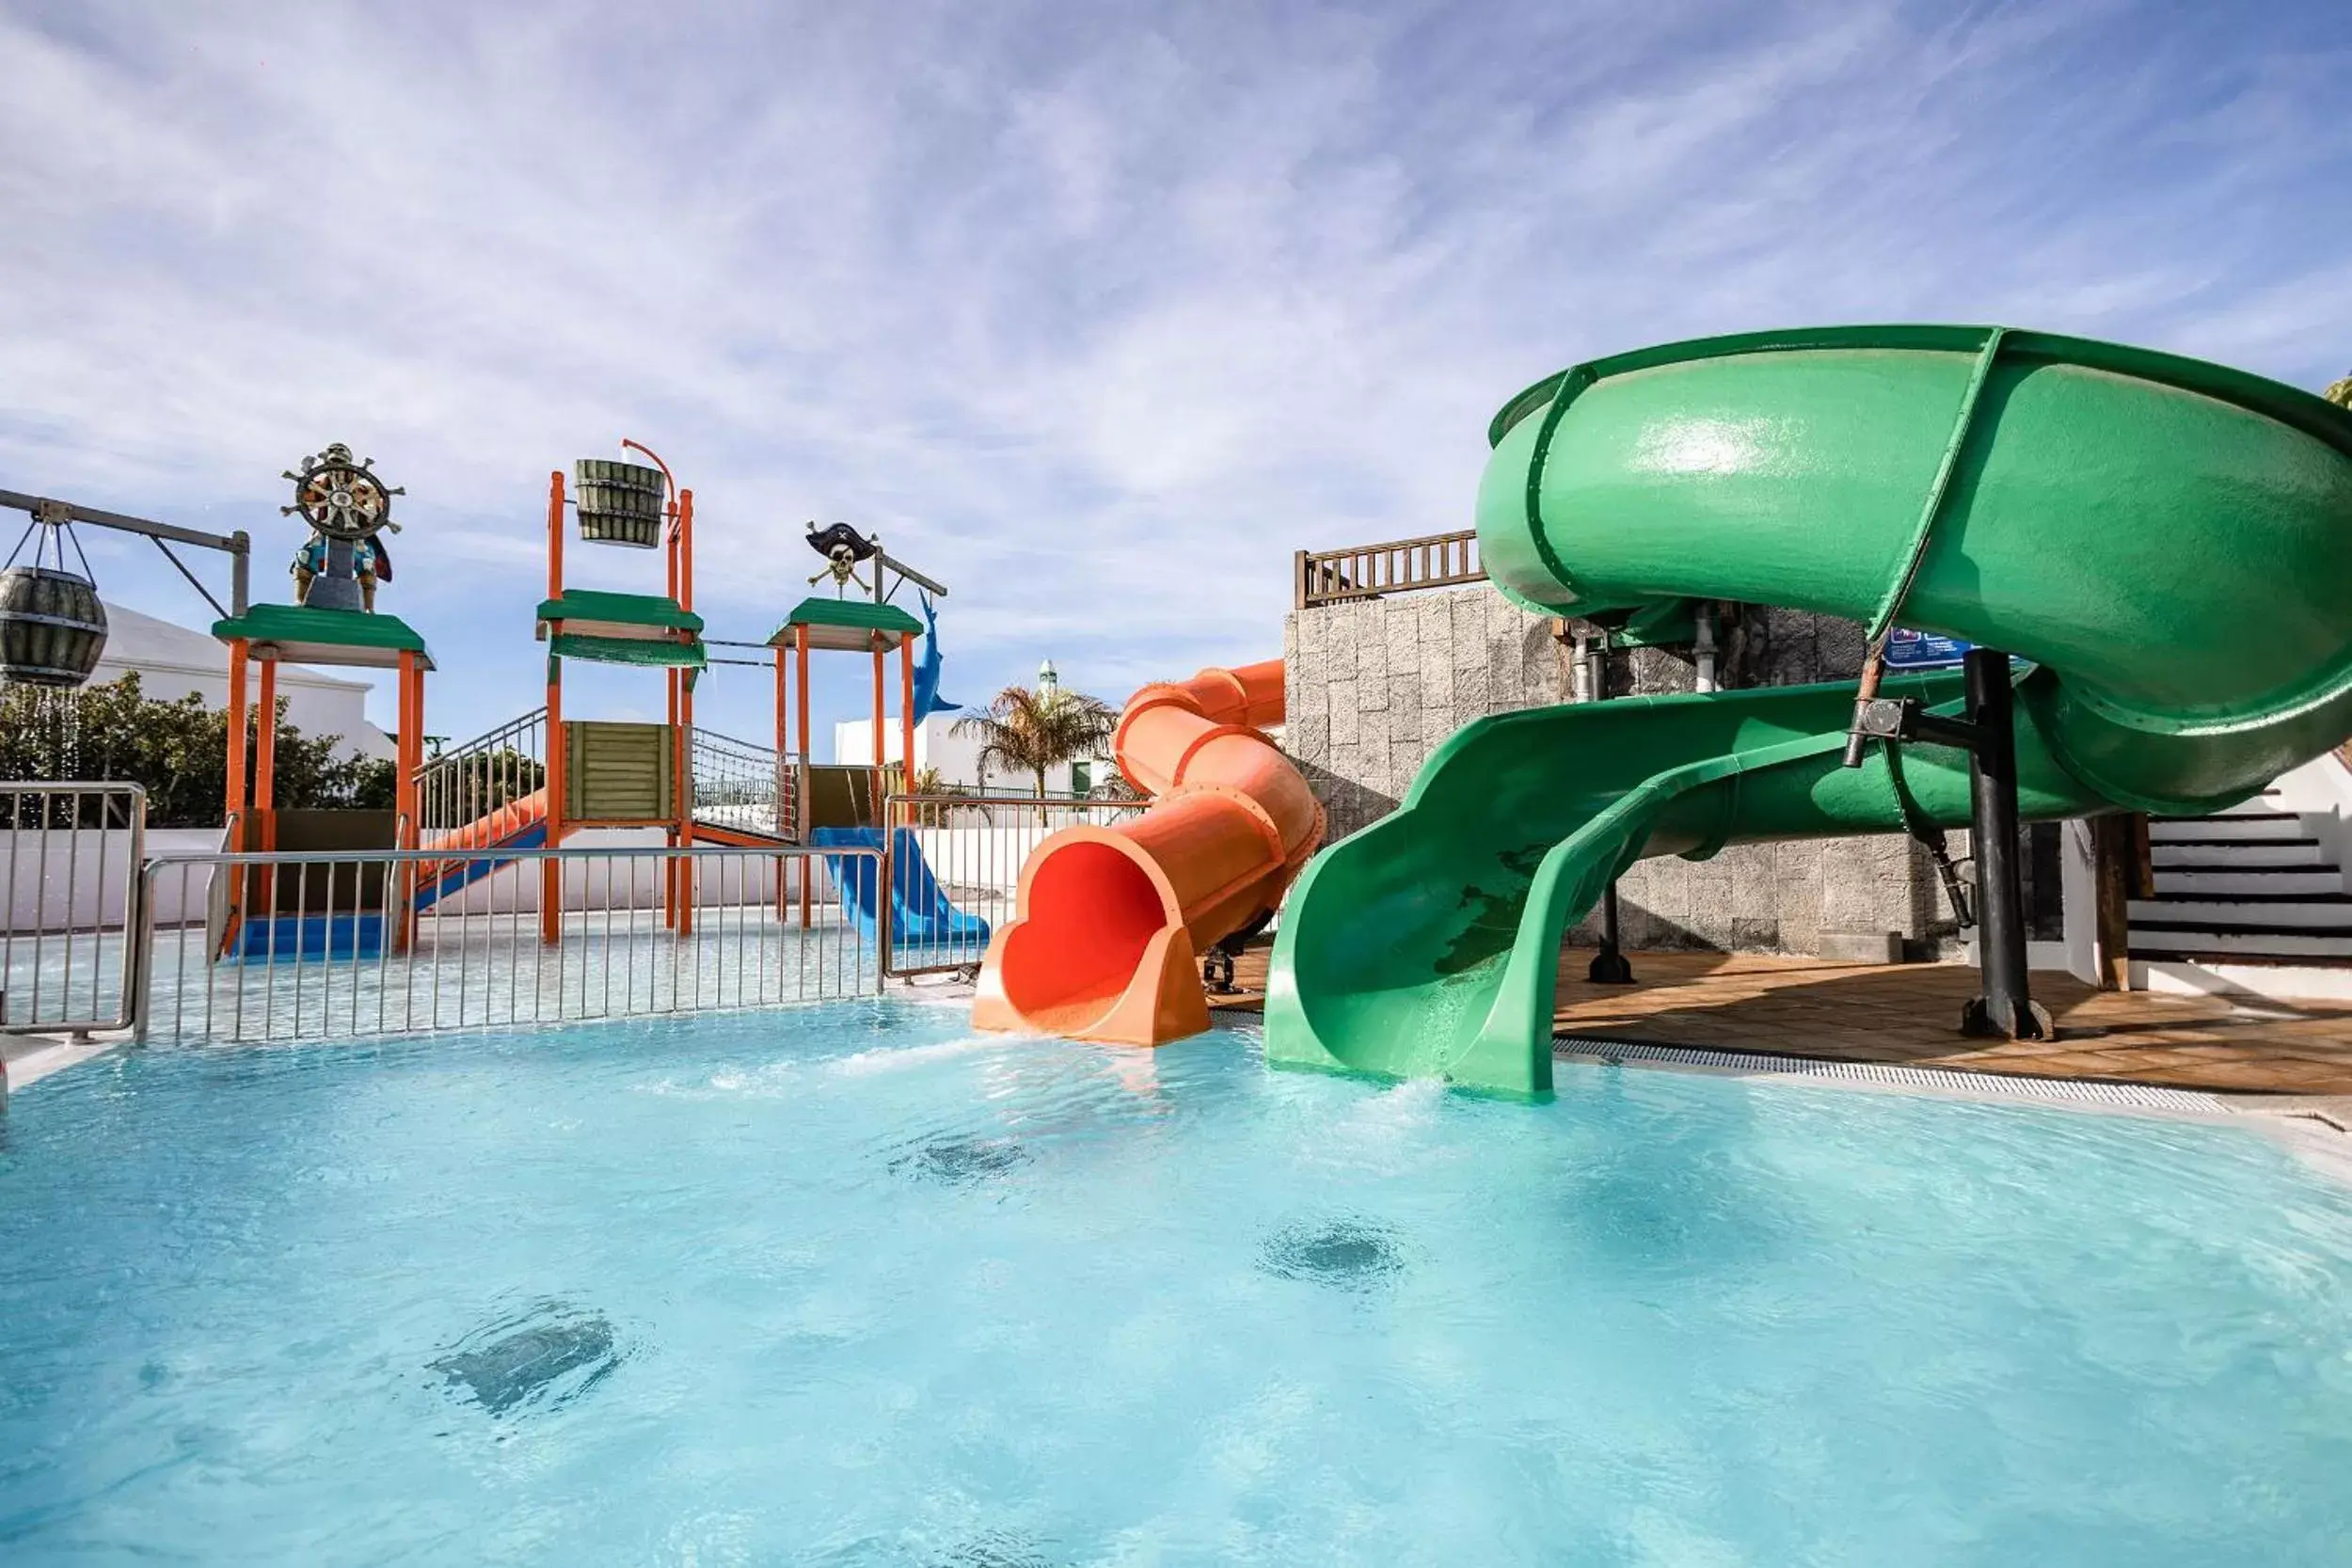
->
2131 780 2352 994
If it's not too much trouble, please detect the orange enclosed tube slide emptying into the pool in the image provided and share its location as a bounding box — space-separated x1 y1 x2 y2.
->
972 658 1325 1046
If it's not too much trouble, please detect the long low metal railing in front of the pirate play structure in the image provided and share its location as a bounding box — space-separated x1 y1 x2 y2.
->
132 847 882 1041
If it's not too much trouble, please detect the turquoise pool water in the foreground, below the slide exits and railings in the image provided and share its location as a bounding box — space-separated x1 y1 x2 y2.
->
0 1002 2352 1568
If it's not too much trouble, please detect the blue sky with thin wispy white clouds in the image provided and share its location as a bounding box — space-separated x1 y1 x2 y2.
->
0 0 2352 738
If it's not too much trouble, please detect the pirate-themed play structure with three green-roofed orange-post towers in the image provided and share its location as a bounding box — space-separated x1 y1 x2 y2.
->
137 442 986 961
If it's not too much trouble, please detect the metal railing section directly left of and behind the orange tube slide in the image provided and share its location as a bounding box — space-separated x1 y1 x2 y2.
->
882 795 1151 975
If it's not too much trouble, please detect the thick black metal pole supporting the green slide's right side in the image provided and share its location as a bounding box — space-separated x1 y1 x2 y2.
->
1960 649 2051 1039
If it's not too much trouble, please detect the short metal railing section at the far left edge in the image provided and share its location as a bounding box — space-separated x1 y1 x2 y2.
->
0 783 146 1035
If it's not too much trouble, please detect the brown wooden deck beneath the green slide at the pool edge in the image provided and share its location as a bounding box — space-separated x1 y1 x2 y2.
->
1212 947 2352 1096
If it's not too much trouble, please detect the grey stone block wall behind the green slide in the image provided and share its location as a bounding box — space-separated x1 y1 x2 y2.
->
1284 588 1966 957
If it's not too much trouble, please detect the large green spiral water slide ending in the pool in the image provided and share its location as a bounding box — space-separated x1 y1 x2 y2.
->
1265 326 2352 1093
